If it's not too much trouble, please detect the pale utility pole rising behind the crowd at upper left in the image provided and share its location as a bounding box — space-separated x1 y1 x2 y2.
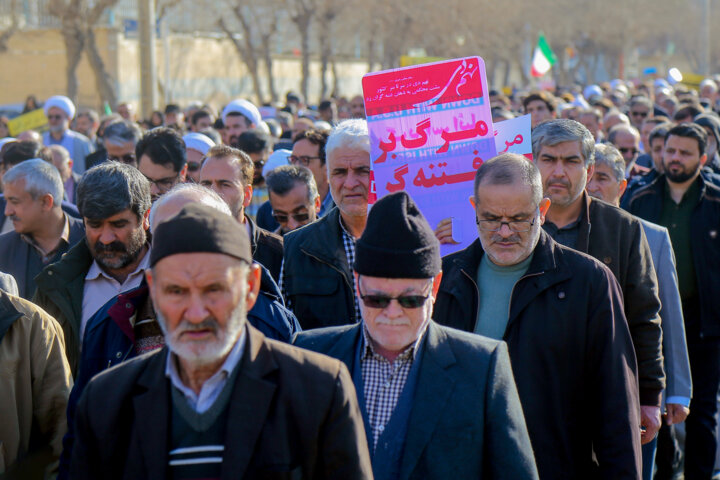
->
138 0 157 118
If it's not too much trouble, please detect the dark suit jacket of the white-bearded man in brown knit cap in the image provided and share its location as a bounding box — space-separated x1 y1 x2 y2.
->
70 326 372 480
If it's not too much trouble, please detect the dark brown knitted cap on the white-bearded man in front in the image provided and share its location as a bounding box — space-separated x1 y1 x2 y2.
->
150 203 252 266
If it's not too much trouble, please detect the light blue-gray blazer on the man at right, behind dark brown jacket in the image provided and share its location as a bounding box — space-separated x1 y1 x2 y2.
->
640 219 692 403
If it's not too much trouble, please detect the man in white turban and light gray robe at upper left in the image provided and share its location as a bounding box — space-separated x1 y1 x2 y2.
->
43 95 95 173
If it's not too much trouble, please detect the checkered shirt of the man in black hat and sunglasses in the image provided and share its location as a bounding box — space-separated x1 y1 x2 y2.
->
360 326 422 452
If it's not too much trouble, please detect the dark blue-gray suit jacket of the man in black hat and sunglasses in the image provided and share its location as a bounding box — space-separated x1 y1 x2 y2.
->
294 322 537 480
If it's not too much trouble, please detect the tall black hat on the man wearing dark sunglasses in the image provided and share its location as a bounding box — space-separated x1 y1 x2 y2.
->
354 192 441 278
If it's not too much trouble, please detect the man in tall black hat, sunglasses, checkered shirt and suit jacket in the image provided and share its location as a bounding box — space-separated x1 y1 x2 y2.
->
295 192 537 480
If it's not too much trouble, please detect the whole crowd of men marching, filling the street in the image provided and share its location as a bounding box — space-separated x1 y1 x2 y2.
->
0 75 720 480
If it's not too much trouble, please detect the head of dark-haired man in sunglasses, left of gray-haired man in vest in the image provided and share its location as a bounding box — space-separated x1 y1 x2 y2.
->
267 165 320 235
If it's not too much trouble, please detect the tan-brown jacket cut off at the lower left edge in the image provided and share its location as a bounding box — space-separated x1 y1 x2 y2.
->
0 291 72 478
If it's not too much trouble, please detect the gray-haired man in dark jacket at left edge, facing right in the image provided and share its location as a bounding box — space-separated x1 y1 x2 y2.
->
0 158 85 300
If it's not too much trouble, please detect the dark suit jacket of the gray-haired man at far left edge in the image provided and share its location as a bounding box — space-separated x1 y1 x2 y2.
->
0 215 85 300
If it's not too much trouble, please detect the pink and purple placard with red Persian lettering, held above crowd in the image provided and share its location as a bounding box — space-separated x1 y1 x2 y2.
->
363 57 496 255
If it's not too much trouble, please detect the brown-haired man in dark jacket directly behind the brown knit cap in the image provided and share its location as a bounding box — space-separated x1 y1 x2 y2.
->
200 145 283 282
